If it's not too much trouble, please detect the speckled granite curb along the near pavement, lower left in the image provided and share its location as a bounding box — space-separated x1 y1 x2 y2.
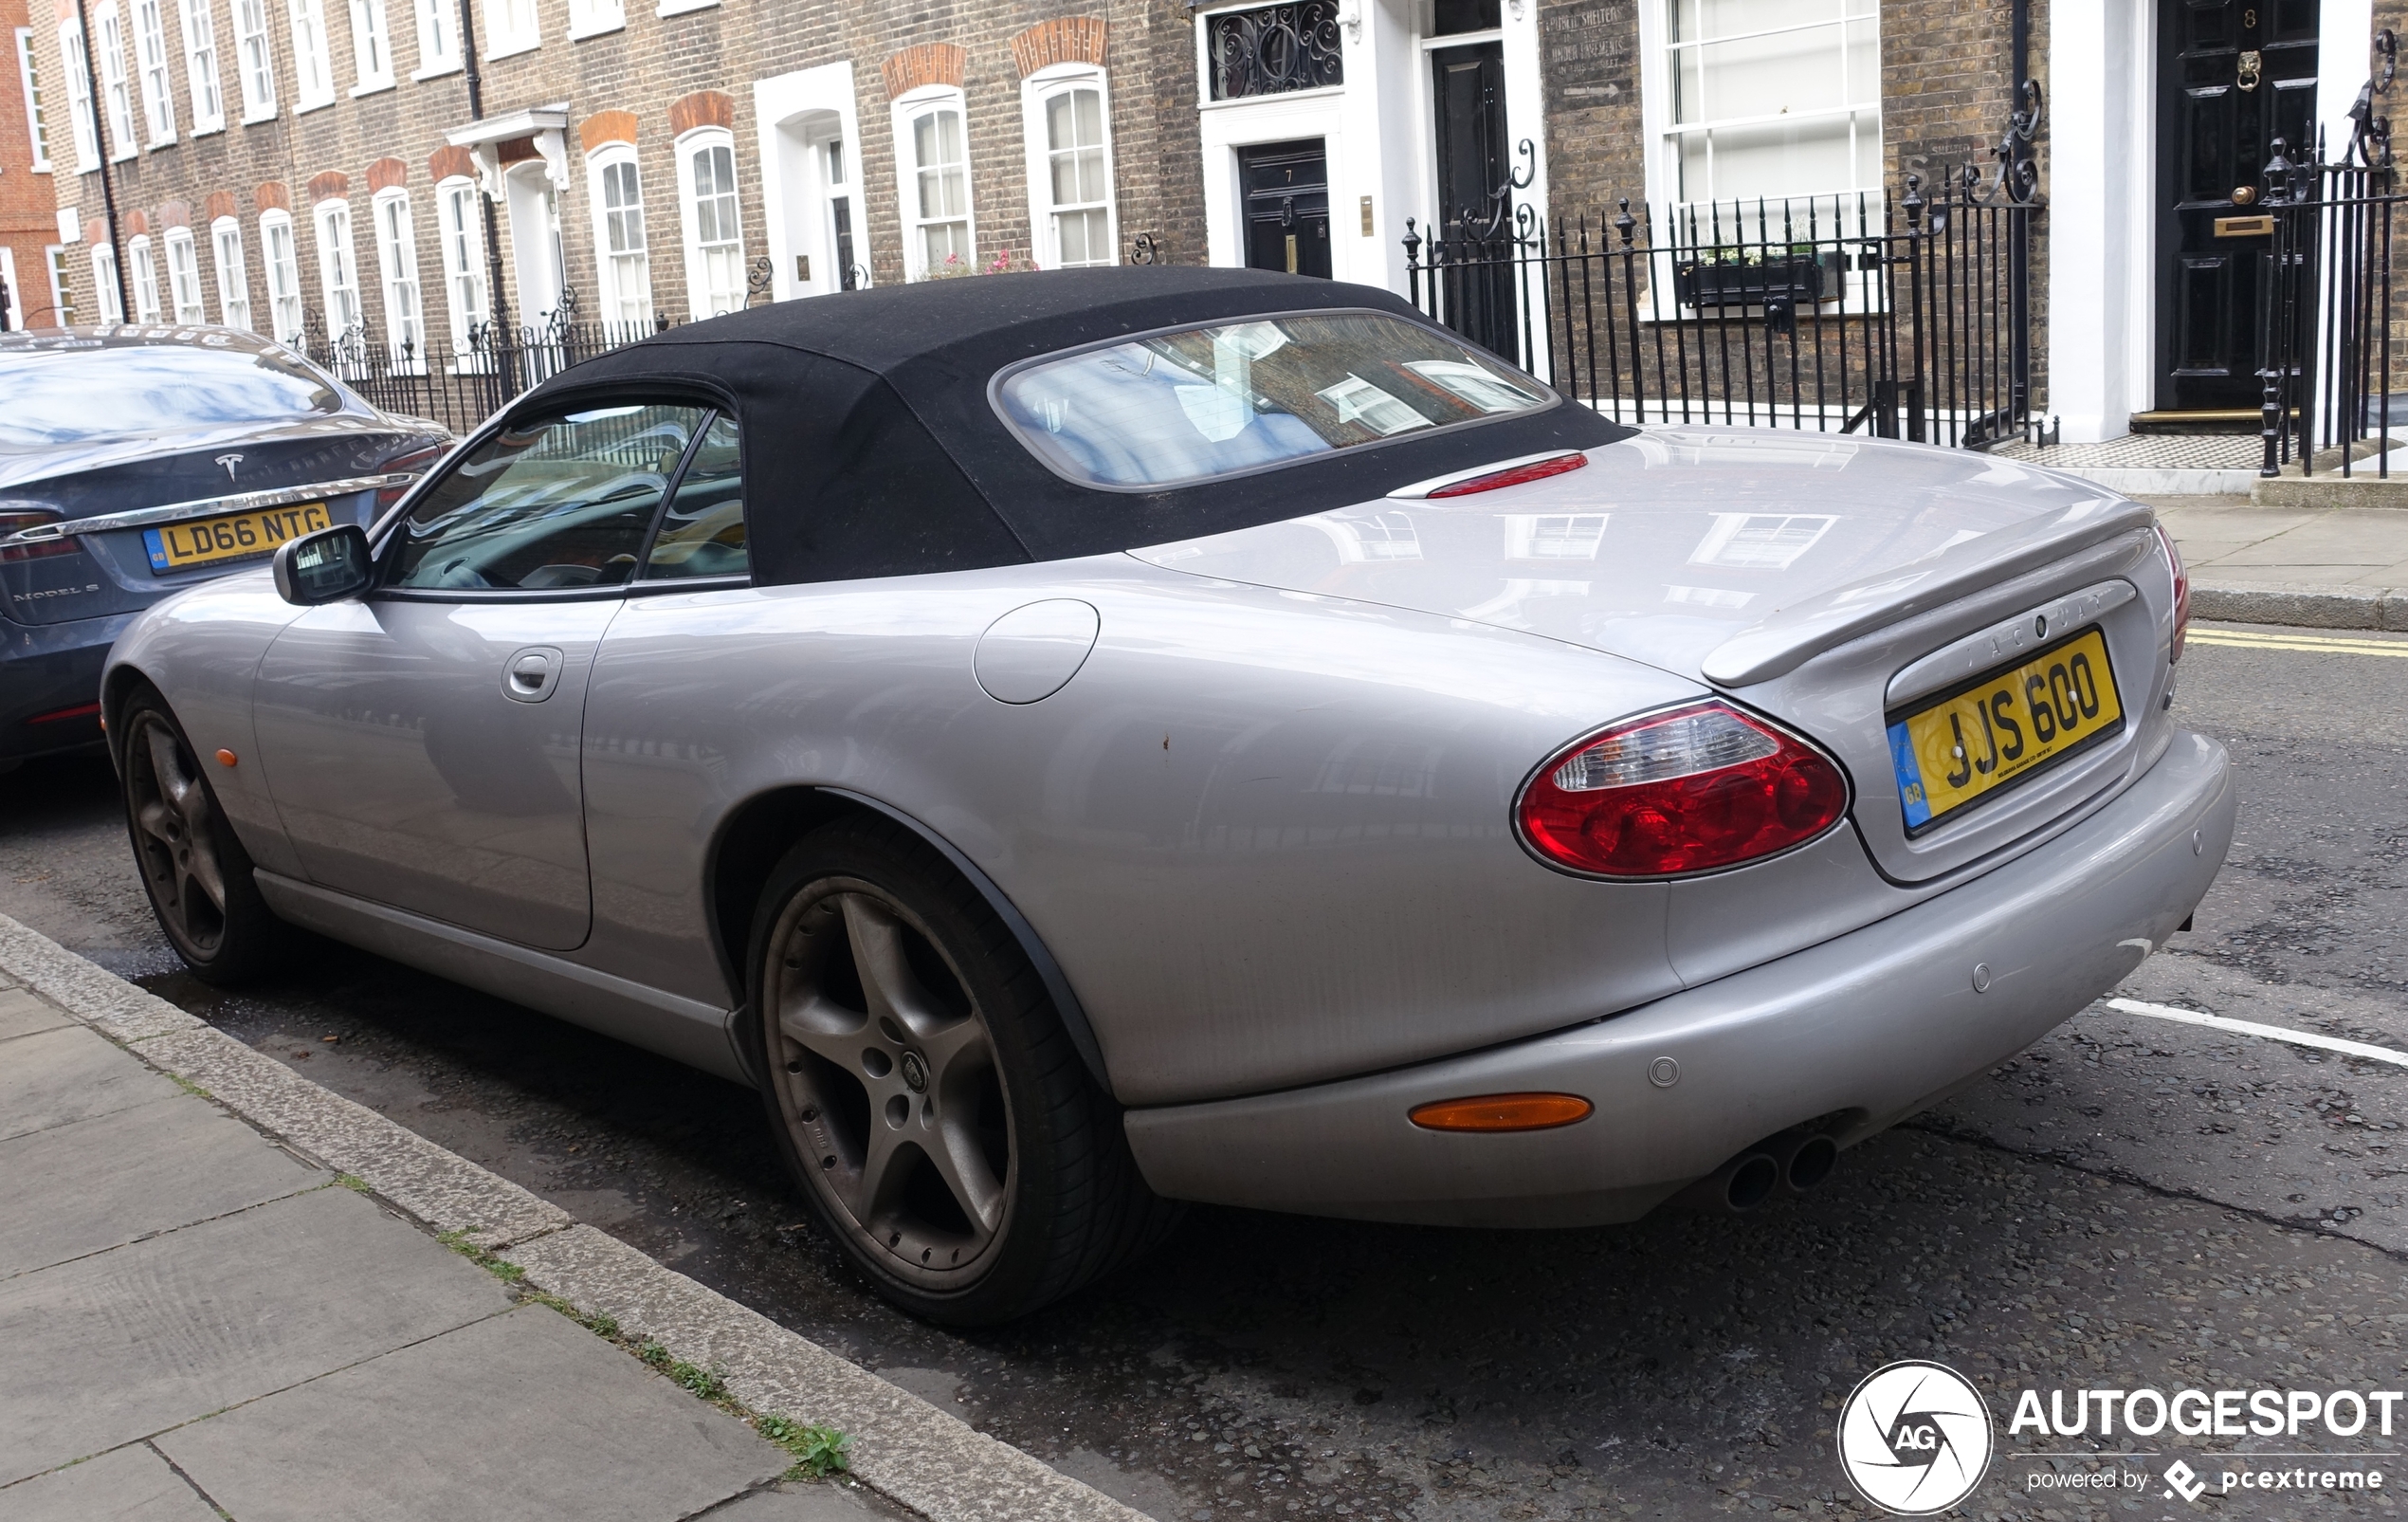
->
0 915 1149 1522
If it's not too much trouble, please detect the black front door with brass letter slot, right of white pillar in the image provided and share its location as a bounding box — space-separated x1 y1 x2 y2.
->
2158 0 2319 412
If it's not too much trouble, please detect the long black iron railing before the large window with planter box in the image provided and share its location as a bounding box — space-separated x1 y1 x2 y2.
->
1404 86 2042 448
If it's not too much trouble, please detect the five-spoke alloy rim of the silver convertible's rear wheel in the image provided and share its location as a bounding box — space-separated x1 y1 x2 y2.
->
763 876 1016 1291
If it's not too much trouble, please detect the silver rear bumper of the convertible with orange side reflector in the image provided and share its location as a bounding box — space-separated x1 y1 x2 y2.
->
1127 732 2235 1226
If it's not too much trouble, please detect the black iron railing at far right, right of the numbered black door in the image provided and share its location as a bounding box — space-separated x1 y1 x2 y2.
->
2259 28 2408 477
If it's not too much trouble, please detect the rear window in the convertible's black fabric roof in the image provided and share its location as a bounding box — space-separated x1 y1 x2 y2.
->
997 313 1556 489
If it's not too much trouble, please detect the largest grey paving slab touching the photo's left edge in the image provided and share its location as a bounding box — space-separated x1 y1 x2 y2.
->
0 1184 510 1486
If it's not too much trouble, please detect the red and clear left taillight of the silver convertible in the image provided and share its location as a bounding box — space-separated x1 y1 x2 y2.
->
1515 701 1847 876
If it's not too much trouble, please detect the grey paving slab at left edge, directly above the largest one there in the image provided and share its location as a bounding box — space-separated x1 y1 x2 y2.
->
0 1093 330 1279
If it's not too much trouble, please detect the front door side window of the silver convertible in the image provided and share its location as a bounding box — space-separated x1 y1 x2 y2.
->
388 405 710 593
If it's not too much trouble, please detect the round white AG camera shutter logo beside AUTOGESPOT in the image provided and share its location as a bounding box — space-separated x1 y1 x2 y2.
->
1840 1358 1997 1517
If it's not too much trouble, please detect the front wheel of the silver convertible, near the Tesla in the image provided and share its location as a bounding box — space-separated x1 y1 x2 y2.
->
116 684 284 987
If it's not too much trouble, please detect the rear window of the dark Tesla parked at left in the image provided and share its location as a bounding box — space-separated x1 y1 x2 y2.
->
0 344 342 450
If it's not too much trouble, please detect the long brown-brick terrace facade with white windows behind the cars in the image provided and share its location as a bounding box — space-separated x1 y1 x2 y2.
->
13 0 2408 438
